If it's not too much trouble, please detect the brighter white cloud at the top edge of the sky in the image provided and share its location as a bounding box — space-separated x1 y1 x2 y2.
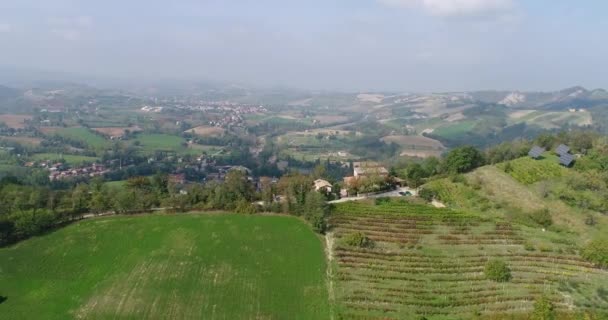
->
378 0 513 16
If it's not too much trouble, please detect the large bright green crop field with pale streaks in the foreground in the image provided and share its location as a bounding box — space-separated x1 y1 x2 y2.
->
0 214 329 320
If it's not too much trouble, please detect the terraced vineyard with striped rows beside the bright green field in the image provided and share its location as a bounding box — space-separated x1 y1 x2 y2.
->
330 203 608 319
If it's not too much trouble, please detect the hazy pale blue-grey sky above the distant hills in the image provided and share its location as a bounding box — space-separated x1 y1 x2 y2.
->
0 0 608 92
